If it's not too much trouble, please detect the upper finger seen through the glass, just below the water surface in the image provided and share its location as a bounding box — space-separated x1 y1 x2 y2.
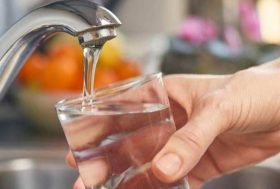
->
62 103 170 150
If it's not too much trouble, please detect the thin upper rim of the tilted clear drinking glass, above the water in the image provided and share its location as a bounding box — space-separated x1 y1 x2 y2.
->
55 72 162 110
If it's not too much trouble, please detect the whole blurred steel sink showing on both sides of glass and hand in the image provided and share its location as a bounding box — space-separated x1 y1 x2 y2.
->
0 147 280 189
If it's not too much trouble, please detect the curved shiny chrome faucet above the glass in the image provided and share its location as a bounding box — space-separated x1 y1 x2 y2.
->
0 0 121 99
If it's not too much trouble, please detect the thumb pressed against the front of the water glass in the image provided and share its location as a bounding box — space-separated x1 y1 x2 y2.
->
152 96 230 183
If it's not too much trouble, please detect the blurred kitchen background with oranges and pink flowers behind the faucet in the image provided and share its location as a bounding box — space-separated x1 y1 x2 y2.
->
0 0 280 146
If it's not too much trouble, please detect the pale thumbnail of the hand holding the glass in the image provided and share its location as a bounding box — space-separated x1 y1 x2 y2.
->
156 153 182 175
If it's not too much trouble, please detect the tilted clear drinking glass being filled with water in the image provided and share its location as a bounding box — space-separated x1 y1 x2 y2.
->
56 73 188 189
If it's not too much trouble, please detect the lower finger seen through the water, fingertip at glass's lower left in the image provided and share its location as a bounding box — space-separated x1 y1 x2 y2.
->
73 123 175 187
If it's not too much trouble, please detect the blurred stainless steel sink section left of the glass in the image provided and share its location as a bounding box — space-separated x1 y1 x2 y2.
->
0 150 78 189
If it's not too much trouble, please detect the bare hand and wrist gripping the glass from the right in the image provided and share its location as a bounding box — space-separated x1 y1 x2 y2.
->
67 60 280 189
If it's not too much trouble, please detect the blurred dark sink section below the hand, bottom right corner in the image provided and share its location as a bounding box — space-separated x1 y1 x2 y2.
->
202 166 280 189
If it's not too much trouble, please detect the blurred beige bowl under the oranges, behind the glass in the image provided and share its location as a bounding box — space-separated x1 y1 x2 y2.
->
16 88 80 136
